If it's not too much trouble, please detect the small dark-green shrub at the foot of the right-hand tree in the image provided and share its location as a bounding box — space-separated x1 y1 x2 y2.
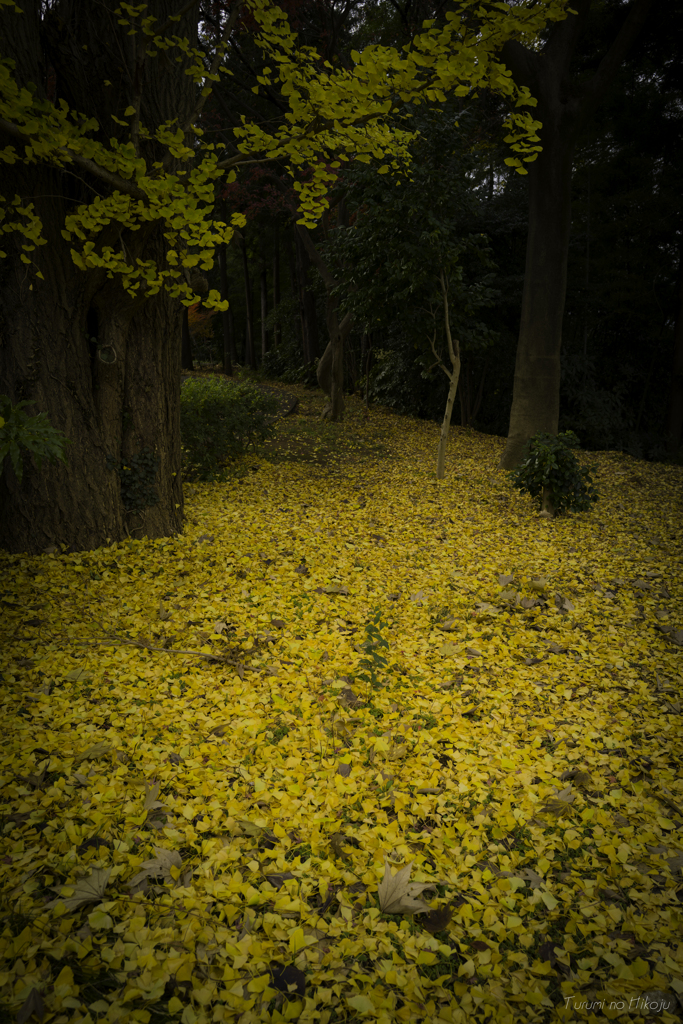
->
508 430 598 513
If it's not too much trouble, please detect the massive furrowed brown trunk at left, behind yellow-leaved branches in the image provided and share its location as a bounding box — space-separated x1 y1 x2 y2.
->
0 0 197 554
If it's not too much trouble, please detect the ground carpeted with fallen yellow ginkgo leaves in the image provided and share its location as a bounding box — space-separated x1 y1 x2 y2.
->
0 386 683 1024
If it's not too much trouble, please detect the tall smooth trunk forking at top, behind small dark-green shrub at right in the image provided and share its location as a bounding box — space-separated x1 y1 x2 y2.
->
500 0 655 469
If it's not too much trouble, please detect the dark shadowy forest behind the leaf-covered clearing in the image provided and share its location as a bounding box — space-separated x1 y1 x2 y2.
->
184 0 683 460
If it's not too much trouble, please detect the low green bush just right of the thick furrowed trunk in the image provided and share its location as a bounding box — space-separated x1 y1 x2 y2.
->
180 377 278 480
